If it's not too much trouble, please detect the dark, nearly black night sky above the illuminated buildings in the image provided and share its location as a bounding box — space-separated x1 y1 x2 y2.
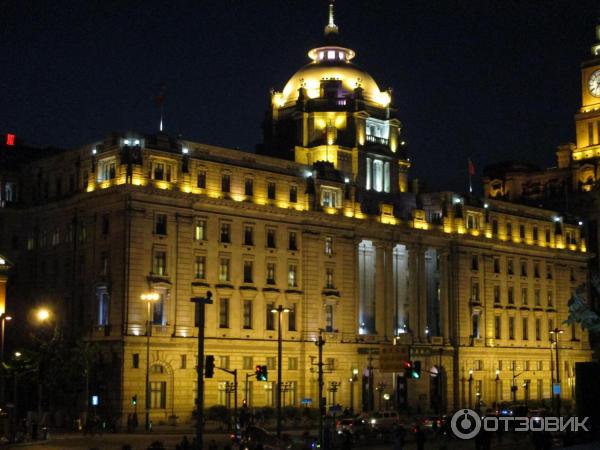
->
0 0 600 190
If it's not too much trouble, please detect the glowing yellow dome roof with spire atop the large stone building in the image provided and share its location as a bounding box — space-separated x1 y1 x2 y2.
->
273 3 391 107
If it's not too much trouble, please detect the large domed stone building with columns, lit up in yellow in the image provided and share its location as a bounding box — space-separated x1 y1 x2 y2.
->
0 3 590 423
